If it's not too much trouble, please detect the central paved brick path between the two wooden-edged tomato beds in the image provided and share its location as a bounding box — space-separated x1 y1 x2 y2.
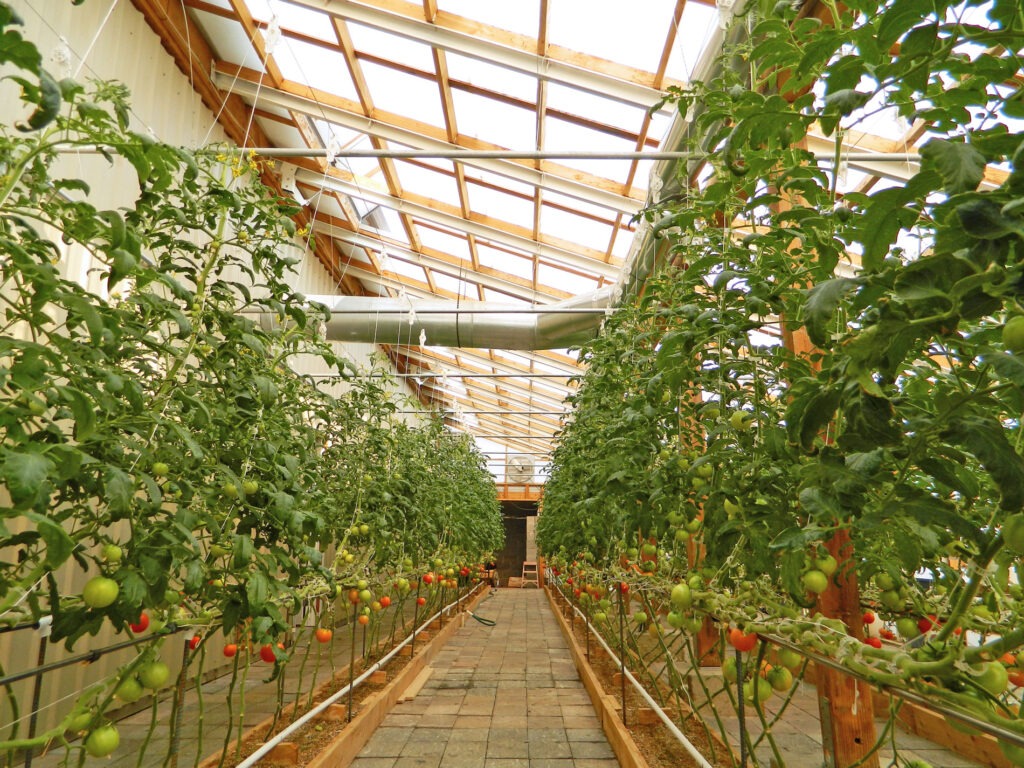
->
352 589 618 768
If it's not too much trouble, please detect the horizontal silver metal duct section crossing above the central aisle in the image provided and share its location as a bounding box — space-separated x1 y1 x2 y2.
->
292 288 612 350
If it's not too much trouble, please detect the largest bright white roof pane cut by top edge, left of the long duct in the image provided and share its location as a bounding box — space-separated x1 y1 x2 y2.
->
548 0 675 72
